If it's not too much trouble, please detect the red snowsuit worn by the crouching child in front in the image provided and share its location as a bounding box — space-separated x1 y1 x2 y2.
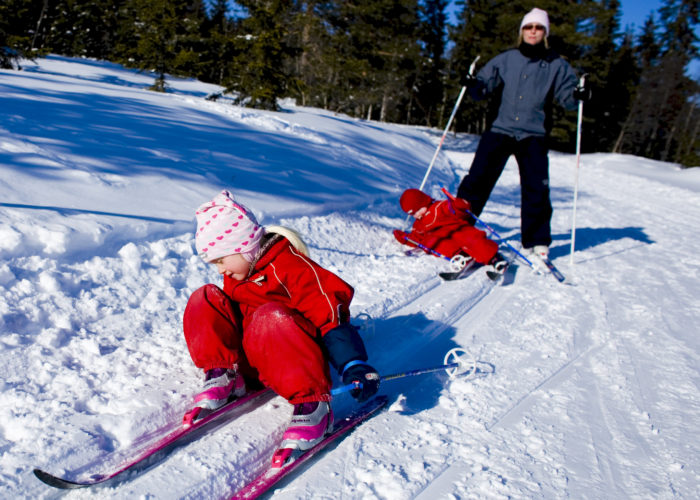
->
183 235 354 404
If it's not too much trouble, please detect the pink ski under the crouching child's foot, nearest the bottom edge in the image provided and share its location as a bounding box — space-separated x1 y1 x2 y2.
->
231 396 388 500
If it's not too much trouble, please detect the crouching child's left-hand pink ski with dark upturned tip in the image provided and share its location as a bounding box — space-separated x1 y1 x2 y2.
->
34 389 275 490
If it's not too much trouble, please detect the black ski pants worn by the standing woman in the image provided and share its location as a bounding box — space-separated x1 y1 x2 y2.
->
457 131 552 248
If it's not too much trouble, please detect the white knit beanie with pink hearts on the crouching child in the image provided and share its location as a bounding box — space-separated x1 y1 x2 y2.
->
194 190 265 262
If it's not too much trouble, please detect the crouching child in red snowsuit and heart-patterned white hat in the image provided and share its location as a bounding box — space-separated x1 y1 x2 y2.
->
183 191 379 458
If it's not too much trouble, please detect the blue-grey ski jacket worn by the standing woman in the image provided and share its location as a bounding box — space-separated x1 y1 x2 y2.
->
469 49 578 140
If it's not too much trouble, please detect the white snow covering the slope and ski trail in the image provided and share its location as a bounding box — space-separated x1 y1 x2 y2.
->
0 56 700 500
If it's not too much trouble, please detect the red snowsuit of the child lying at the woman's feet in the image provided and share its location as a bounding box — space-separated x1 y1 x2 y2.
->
394 198 498 264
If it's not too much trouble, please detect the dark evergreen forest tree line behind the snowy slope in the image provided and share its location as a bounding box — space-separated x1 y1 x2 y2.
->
0 0 700 166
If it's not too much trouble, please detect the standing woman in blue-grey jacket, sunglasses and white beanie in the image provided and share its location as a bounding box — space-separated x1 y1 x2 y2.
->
457 8 588 257
